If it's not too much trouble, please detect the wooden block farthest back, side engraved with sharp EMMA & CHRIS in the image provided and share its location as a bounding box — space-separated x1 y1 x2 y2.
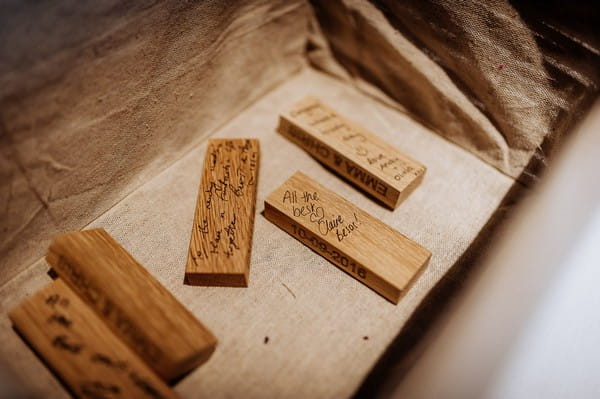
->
277 97 426 209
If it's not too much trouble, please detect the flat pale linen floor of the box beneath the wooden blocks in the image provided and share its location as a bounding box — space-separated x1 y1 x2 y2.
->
0 69 513 398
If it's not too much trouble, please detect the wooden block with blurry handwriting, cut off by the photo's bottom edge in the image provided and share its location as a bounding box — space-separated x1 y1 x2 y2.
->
9 279 177 399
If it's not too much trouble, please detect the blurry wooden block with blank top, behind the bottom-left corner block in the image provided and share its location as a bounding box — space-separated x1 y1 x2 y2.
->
46 229 217 381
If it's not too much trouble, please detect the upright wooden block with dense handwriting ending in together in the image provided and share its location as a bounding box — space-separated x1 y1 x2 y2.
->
185 139 259 287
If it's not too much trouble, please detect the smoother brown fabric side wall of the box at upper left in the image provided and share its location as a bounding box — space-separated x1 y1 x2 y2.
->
0 0 308 284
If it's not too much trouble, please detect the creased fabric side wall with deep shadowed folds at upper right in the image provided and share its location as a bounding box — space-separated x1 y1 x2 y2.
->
308 0 600 183
